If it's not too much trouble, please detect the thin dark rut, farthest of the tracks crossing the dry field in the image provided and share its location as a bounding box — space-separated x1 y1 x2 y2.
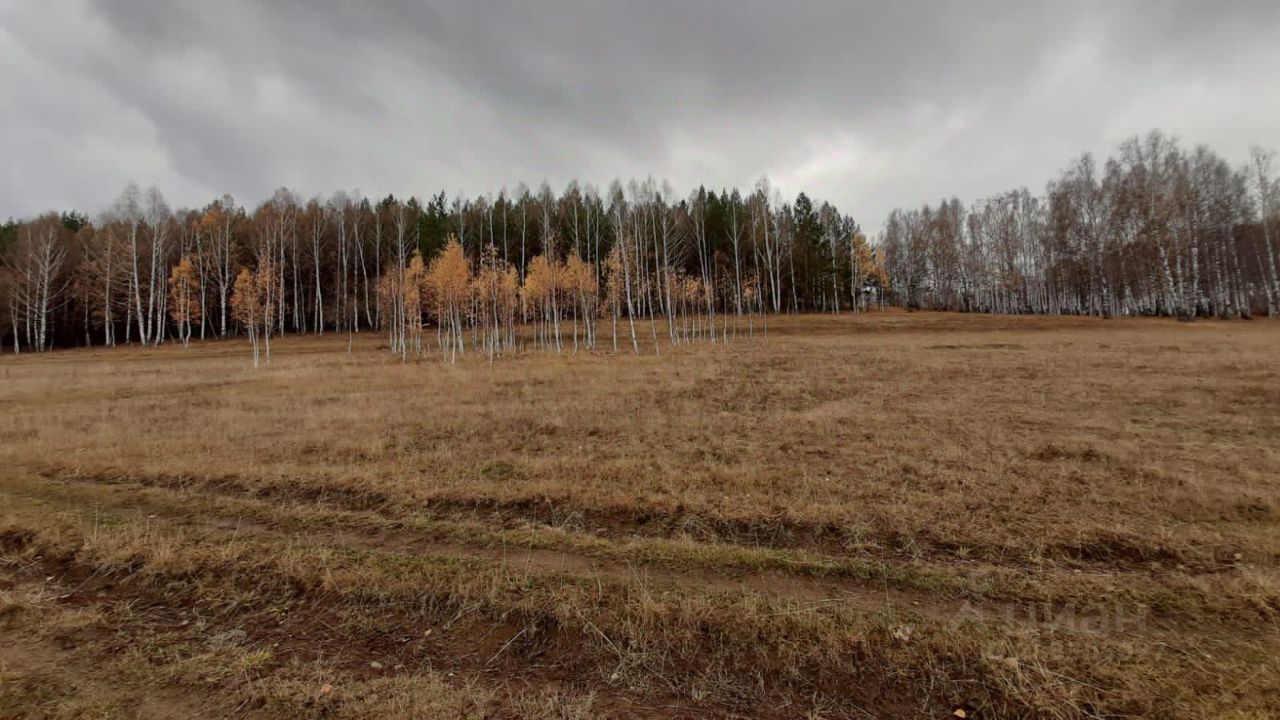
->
27 464 1239 575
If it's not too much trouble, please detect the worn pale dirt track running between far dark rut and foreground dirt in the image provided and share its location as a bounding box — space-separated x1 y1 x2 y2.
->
0 475 1213 633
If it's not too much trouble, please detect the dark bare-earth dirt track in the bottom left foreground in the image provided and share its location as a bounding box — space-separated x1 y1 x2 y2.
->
0 543 732 720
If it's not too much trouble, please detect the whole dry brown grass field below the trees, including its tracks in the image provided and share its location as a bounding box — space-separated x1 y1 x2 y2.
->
0 313 1280 719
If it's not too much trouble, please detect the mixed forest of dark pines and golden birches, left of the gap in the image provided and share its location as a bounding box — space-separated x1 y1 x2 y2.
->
0 179 887 360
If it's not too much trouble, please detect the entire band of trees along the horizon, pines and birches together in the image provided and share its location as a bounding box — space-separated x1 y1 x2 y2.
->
0 131 1280 359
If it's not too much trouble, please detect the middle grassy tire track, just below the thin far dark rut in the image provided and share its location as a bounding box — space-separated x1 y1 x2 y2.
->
0 466 1208 632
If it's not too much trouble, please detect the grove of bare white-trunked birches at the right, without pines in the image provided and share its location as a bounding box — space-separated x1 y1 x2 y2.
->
879 131 1280 319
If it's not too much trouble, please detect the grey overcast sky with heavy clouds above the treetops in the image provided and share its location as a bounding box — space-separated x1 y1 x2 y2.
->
0 0 1280 231
